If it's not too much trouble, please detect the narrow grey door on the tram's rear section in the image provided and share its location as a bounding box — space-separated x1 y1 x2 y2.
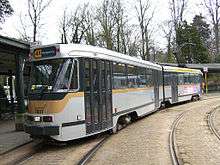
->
171 74 178 103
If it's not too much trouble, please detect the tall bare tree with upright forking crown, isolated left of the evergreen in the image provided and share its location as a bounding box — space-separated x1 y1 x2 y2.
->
135 0 154 61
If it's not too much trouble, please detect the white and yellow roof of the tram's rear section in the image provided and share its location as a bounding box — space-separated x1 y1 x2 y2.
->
163 66 202 74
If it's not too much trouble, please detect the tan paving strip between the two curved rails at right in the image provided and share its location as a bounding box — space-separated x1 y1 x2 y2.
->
176 98 220 165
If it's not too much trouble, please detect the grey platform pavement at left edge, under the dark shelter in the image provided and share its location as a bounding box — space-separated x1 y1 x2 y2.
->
0 120 31 154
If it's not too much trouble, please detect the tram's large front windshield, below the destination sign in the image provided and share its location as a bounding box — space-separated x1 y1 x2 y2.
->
30 59 78 93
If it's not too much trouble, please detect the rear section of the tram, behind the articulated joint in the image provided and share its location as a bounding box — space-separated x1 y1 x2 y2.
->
163 66 203 104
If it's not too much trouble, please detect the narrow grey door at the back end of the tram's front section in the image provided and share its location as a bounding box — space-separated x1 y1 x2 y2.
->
153 70 160 108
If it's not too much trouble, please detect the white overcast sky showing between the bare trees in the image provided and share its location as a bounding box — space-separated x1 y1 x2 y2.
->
0 0 204 49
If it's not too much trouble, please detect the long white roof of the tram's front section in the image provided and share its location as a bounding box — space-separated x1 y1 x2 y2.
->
32 44 162 70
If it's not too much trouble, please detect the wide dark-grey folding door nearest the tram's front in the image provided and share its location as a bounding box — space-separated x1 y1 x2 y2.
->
84 59 112 134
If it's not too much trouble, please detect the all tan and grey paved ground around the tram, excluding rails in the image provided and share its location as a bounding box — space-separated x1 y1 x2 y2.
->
0 94 220 165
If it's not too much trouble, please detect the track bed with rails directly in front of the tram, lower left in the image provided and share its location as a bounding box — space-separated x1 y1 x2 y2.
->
7 134 109 165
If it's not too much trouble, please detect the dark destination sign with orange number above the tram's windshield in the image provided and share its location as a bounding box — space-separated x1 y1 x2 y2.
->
33 47 56 59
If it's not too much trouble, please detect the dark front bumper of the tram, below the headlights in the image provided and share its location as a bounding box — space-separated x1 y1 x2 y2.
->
24 125 59 136
